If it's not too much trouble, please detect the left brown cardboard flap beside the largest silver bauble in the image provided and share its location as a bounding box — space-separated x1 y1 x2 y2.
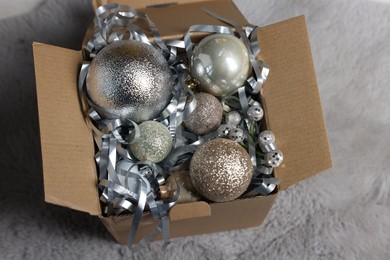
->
33 43 101 215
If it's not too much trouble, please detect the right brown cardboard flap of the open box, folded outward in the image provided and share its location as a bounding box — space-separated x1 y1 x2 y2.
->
259 16 332 189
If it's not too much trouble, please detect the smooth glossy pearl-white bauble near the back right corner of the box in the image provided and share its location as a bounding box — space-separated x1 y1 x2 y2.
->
190 34 252 96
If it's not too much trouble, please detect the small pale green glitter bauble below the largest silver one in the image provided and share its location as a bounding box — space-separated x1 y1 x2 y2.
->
129 121 172 163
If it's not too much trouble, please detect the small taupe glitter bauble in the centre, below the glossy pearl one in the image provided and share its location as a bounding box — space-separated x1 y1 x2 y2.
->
183 92 223 135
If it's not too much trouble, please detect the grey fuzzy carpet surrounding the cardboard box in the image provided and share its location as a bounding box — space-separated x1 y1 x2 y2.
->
0 0 390 259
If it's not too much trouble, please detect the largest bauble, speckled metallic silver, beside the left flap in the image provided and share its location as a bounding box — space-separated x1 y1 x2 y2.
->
87 40 173 123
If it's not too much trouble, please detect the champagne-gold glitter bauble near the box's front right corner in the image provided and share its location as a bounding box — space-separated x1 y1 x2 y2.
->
190 138 253 202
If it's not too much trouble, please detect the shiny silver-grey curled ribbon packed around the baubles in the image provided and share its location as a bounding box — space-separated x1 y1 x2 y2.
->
78 4 277 250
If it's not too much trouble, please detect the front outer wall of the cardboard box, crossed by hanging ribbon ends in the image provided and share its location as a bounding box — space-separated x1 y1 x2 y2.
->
100 194 277 244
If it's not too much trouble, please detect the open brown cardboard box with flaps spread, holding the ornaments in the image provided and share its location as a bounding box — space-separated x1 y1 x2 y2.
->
33 0 332 244
